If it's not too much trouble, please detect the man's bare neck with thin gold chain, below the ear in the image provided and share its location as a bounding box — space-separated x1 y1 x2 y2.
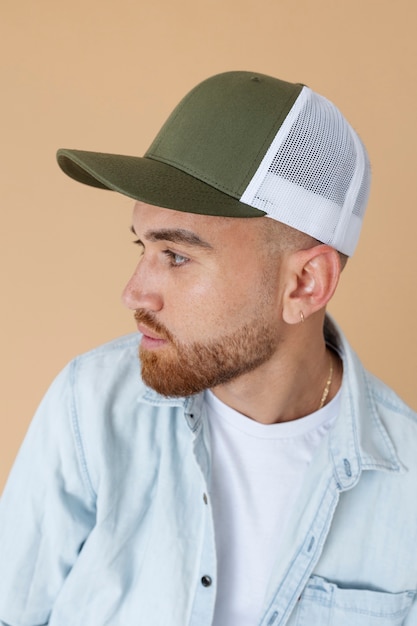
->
212 320 342 424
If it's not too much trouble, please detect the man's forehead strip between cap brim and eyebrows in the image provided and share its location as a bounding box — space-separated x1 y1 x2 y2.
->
133 202 266 247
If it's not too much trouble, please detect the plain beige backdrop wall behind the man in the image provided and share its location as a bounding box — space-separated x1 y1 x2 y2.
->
0 0 417 489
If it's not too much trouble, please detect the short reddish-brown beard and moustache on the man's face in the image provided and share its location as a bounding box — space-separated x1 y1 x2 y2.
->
135 309 278 397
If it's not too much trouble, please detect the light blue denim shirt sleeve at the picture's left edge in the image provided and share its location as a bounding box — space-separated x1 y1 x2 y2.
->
0 364 95 626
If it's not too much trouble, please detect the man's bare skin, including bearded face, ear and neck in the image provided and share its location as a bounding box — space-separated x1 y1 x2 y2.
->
123 202 341 423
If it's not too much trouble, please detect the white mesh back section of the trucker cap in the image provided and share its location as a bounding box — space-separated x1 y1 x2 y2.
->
241 87 369 255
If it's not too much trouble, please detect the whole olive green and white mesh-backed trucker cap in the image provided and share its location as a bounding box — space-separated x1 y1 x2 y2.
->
57 72 370 256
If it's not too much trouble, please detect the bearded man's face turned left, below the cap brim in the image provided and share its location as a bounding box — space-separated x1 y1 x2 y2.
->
123 203 281 396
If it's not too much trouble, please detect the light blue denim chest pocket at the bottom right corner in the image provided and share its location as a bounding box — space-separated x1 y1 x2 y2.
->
291 576 415 626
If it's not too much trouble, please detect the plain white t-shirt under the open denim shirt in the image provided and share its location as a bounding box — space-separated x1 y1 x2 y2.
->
205 391 339 626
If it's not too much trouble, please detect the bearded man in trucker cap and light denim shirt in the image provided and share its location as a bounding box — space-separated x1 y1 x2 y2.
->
0 72 417 626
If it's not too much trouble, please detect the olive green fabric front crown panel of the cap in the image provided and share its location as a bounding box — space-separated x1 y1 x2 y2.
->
145 72 302 199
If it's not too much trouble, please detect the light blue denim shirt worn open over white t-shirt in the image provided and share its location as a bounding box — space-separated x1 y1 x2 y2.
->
0 319 417 626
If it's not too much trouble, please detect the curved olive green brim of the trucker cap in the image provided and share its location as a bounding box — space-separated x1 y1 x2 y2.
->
57 149 265 217
